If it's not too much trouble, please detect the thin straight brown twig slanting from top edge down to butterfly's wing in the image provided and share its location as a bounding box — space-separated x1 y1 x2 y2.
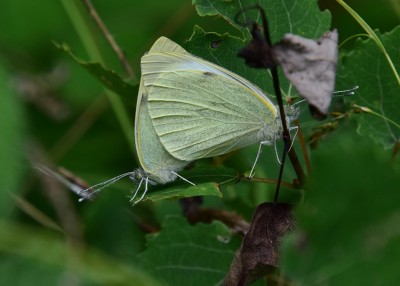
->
83 0 136 80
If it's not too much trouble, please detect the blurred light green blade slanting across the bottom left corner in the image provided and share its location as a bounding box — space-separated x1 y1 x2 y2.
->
0 221 160 286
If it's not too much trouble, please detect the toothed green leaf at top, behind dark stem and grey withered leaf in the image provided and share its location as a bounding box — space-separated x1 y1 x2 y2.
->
187 0 331 100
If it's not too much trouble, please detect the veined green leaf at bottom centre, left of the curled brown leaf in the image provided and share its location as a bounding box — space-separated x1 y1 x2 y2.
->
138 217 239 286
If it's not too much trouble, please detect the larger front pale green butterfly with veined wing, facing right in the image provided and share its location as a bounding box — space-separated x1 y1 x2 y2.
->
141 37 296 177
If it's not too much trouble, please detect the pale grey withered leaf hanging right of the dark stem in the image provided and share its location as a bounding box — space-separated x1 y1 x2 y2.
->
273 30 338 119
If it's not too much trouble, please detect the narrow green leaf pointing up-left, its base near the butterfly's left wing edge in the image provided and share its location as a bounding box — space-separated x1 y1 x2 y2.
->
54 43 137 98
